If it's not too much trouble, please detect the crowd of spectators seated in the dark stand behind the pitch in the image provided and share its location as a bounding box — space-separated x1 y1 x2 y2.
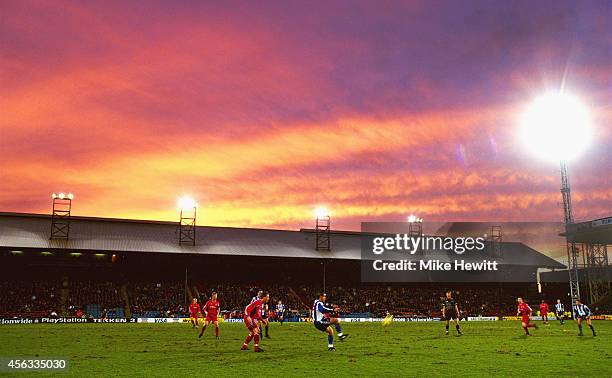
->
0 281 606 318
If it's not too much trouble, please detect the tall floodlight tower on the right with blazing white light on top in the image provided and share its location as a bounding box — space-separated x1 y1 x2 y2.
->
522 92 592 303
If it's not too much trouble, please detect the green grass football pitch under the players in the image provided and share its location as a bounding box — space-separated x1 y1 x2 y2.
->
0 321 612 377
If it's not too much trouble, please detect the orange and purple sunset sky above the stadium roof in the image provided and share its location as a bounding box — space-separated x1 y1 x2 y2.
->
0 0 612 230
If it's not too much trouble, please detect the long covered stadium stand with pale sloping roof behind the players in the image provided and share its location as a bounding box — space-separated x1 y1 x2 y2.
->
0 213 592 317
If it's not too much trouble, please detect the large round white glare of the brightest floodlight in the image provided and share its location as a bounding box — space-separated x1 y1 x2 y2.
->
521 93 593 162
